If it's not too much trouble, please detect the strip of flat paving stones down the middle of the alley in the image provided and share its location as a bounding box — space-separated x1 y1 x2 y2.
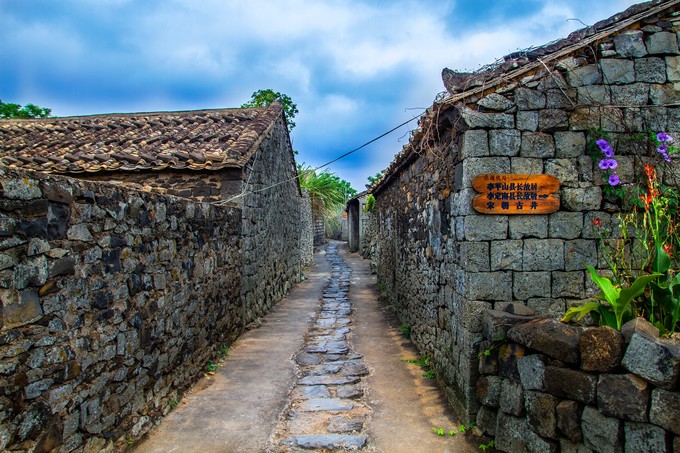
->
275 243 370 451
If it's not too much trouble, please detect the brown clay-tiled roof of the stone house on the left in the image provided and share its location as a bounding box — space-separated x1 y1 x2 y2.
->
0 103 282 173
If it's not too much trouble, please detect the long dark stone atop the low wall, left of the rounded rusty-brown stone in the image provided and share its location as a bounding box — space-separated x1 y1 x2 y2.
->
508 319 583 364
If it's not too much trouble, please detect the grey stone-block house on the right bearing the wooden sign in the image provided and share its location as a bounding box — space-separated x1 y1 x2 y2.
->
370 1 680 444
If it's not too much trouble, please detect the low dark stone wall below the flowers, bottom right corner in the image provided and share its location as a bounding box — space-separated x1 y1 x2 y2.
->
477 305 680 453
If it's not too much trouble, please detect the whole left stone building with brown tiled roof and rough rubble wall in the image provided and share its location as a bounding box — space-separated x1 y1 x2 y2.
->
0 103 306 451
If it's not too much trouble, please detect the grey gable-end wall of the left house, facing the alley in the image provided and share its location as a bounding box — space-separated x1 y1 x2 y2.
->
242 117 302 322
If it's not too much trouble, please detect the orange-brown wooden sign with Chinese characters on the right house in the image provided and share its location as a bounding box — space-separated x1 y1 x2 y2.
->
472 174 560 214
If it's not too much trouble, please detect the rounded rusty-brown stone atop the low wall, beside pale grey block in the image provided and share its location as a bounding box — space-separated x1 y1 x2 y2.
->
579 326 625 372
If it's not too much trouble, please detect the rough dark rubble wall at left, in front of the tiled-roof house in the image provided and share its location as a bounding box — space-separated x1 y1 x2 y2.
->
0 169 241 452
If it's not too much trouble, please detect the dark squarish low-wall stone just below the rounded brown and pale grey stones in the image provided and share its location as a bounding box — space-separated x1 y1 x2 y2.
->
597 374 650 422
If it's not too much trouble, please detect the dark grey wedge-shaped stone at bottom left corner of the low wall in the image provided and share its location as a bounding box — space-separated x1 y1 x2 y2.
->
496 412 558 453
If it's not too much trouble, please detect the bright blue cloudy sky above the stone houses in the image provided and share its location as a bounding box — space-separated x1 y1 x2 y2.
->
0 0 637 191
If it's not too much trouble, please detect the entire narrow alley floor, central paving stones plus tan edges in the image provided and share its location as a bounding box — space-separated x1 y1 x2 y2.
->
135 242 479 453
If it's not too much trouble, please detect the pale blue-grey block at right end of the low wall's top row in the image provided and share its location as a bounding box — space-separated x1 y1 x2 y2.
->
621 333 680 390
